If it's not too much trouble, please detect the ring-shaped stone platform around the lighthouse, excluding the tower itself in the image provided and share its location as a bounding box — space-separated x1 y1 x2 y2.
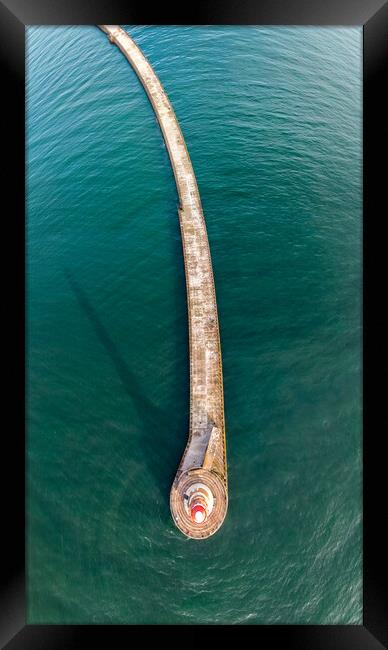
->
170 467 228 539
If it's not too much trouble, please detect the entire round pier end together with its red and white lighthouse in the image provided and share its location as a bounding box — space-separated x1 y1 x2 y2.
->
170 467 228 539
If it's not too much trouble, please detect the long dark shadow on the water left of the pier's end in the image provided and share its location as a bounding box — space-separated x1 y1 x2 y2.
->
64 269 185 503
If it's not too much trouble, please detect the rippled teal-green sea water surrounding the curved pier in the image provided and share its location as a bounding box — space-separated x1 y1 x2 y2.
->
26 26 362 623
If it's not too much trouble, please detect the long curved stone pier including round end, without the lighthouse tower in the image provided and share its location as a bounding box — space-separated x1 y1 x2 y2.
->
99 25 228 539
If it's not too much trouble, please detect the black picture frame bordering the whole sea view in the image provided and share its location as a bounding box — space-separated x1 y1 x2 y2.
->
0 0 388 650
